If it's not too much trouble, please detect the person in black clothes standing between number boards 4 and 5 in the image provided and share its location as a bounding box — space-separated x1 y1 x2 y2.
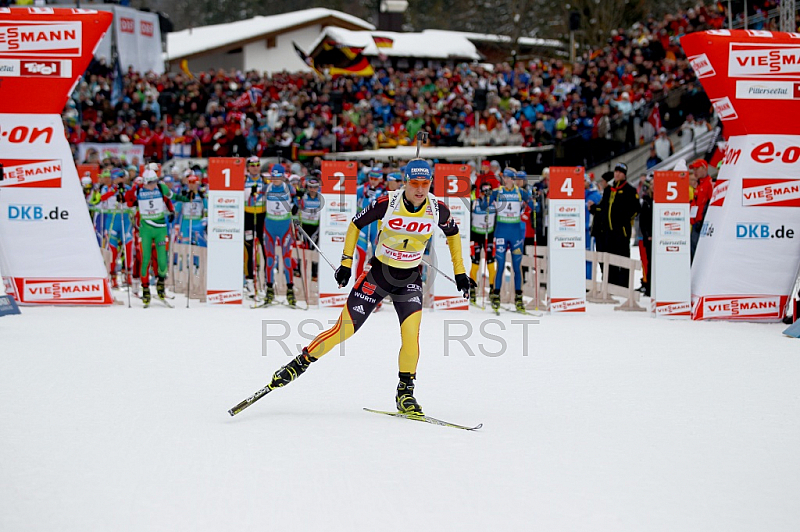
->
589 163 641 288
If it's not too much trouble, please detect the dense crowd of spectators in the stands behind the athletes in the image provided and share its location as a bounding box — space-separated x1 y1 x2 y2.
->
64 3 752 166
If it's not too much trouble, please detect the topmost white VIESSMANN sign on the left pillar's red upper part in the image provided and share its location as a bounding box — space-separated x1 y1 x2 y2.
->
0 22 82 57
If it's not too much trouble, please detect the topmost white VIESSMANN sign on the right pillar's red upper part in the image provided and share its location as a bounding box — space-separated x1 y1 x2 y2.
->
728 43 800 78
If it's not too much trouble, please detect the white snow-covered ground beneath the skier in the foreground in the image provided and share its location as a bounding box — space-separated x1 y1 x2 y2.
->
0 296 800 532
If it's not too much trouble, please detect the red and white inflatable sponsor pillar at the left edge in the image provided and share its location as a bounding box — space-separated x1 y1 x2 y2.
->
0 8 113 305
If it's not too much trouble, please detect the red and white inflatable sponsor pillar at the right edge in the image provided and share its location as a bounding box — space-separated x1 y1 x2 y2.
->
681 30 800 321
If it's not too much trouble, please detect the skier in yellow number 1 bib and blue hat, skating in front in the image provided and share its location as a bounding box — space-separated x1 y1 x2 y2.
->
238 159 474 416
